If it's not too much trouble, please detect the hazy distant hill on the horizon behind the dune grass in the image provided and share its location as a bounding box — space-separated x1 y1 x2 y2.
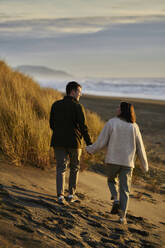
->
14 65 72 79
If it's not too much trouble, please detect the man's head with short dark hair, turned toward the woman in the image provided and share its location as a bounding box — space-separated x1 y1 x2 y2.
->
66 81 81 101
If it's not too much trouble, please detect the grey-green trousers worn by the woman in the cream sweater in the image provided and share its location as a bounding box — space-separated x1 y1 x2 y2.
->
107 164 133 217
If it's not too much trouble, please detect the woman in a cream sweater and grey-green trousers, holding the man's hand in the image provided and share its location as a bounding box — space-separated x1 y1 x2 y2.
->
86 102 148 224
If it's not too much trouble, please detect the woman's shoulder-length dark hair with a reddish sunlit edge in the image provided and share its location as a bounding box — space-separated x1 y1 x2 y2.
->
118 102 136 123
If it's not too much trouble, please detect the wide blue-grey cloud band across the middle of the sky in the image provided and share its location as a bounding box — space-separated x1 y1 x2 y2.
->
0 22 165 55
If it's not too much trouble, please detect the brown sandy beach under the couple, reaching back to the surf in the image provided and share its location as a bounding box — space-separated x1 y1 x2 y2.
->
0 95 165 248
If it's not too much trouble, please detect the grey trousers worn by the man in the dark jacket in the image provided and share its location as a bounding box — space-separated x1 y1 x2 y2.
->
54 147 82 196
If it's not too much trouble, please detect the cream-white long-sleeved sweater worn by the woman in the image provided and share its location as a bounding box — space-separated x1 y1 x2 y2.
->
86 117 148 171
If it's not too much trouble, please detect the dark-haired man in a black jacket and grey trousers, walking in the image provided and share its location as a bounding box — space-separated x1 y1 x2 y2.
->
50 81 91 204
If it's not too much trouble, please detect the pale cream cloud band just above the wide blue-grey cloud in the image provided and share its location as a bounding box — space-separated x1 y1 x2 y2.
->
0 15 165 38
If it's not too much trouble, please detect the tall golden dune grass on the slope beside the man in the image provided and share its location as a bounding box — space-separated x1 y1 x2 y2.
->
0 61 103 168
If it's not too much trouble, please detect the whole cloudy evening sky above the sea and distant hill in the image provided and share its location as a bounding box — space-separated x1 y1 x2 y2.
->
0 0 165 78
